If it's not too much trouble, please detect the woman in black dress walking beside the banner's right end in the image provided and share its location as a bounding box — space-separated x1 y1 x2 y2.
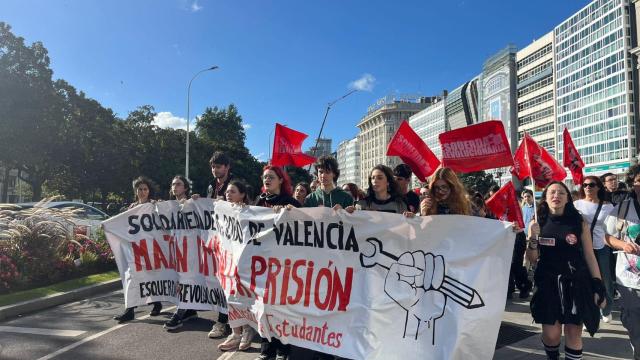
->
527 181 606 360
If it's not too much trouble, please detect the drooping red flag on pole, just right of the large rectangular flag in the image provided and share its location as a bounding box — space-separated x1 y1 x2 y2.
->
511 133 567 187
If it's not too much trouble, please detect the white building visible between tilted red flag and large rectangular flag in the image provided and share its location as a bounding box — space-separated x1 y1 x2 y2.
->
409 92 451 186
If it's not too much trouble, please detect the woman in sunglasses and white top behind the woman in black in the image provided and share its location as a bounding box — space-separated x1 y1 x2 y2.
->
573 176 613 323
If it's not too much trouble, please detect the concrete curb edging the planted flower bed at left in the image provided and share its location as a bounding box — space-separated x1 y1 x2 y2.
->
0 278 122 321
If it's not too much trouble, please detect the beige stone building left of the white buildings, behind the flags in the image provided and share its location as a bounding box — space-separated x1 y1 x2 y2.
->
358 95 428 189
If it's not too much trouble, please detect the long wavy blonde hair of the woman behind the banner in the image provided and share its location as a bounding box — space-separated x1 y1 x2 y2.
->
426 167 471 215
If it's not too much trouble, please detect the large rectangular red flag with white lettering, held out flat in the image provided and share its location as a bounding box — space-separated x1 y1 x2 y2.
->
438 120 513 172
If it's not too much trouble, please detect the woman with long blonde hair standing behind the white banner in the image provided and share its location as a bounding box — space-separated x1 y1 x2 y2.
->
420 167 471 216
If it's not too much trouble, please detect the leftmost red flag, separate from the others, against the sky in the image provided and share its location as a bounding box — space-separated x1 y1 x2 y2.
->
271 123 316 167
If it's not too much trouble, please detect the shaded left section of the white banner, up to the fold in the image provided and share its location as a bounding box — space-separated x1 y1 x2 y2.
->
103 199 227 313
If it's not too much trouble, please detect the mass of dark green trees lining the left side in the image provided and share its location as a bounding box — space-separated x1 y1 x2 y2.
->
0 22 261 203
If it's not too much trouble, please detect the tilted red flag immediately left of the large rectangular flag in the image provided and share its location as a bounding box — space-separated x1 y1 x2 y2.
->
387 120 440 181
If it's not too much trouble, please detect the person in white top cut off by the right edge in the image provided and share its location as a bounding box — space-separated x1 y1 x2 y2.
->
605 165 640 360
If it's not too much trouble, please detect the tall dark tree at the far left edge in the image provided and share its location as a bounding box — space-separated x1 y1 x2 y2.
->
0 22 64 201
